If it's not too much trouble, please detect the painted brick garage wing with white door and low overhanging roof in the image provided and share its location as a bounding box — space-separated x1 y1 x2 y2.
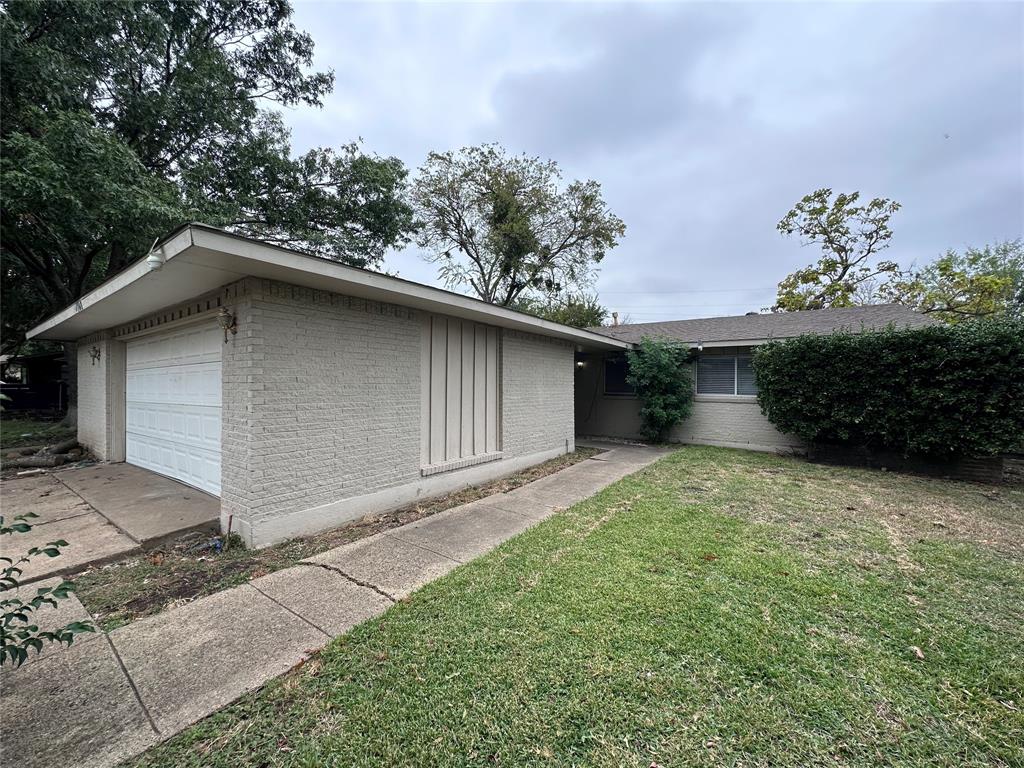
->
29 224 630 546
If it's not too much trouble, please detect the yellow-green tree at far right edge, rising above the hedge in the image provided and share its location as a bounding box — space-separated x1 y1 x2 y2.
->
880 240 1024 323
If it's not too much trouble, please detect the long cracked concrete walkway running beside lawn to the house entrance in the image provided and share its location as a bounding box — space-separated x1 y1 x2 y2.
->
0 444 666 768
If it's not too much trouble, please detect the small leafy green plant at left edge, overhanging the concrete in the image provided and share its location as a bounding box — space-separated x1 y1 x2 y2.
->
0 512 96 667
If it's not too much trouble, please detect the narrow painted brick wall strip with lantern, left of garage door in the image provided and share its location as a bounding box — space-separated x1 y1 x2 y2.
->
77 332 125 461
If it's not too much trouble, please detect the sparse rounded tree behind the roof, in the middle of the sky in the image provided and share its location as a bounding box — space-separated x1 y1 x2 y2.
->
413 144 626 306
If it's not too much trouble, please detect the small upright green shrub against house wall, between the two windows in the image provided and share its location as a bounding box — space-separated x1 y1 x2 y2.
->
626 338 693 441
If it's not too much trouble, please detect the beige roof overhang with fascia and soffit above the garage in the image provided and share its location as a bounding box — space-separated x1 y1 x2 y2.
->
28 223 633 351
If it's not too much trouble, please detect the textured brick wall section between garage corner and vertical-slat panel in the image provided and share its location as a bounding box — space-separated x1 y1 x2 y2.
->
222 281 420 527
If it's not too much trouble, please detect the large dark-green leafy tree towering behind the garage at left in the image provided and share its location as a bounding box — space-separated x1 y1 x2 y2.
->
0 0 413 349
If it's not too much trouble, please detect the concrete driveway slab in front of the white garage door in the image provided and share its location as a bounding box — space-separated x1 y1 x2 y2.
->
0 464 220 584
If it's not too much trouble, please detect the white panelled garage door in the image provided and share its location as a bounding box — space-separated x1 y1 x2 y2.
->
125 323 224 496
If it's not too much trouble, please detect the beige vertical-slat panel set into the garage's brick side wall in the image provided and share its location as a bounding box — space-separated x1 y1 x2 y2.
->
422 316 501 475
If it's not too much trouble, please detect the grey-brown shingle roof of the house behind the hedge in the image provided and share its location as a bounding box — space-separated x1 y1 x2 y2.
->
590 304 936 344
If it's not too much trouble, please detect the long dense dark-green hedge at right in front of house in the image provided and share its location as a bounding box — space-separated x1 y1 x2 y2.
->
754 321 1024 458
